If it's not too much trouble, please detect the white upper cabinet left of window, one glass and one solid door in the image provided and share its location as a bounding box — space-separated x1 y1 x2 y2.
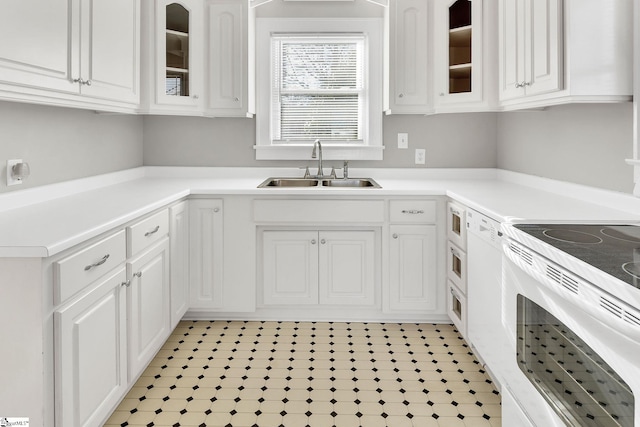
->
141 0 253 117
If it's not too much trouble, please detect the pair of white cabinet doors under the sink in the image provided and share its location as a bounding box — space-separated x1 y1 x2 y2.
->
262 230 376 306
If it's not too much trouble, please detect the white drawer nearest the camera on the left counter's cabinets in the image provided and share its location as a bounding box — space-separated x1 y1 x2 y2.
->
53 230 127 304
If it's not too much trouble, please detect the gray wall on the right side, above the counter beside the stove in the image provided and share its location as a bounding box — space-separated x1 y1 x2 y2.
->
497 103 633 193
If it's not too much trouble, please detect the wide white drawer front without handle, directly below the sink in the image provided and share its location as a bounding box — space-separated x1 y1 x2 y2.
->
253 199 384 225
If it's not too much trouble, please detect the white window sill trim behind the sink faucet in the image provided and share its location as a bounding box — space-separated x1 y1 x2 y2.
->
253 144 384 160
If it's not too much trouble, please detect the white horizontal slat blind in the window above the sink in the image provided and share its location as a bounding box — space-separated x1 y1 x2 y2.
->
271 34 366 144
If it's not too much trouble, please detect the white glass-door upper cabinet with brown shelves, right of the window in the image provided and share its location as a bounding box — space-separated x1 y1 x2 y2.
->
433 0 497 112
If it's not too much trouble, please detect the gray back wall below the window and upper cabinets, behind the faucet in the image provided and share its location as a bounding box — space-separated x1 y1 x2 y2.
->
144 113 496 168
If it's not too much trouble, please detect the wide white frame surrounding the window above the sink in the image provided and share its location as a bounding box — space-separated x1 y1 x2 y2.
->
254 18 384 160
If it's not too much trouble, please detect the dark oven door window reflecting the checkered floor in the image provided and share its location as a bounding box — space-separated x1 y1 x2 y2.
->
517 295 634 427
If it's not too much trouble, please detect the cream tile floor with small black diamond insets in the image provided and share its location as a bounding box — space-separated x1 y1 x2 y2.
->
105 321 501 427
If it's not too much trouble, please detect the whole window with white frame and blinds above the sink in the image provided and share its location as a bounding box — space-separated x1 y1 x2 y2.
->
255 18 382 160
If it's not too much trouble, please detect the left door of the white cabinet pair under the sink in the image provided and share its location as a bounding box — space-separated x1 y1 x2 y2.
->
262 231 318 304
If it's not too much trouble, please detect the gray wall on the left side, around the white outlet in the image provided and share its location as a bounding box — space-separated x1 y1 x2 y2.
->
0 102 143 192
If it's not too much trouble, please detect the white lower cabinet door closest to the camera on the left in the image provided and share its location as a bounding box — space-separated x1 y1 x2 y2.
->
54 267 127 427
